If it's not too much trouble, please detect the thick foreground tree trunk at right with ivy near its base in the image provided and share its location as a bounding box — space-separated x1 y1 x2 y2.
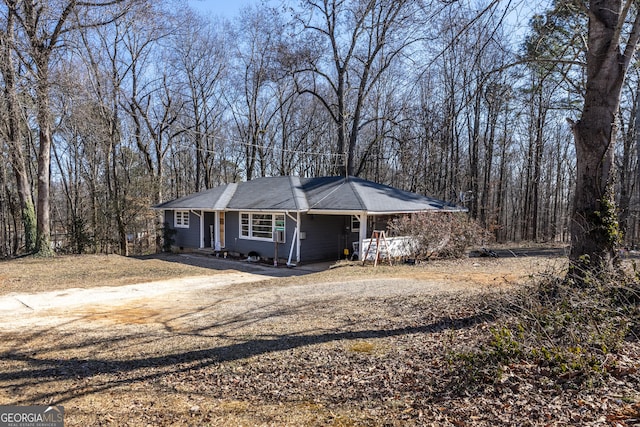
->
570 0 640 282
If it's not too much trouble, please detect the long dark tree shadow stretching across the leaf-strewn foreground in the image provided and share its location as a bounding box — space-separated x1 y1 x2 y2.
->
0 306 489 405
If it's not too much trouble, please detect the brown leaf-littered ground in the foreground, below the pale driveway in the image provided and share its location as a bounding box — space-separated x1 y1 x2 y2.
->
0 254 640 426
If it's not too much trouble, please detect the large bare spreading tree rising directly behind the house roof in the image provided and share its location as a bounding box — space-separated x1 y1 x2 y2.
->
297 0 416 175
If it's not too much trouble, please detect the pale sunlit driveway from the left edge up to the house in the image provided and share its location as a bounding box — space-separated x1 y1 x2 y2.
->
0 254 329 331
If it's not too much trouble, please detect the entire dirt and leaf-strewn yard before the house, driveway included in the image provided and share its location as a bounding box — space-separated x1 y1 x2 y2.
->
0 250 633 426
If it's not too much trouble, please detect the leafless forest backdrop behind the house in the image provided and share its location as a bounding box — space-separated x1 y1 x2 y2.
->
0 0 640 256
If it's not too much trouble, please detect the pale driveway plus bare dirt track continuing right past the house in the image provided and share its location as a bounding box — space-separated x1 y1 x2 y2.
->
0 256 528 332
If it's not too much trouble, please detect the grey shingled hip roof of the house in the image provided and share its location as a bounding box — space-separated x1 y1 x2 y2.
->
155 176 466 214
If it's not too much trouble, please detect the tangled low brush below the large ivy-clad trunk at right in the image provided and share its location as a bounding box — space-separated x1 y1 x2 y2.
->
451 274 640 387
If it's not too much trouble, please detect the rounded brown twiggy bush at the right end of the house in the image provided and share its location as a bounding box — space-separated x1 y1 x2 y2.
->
389 212 492 259
